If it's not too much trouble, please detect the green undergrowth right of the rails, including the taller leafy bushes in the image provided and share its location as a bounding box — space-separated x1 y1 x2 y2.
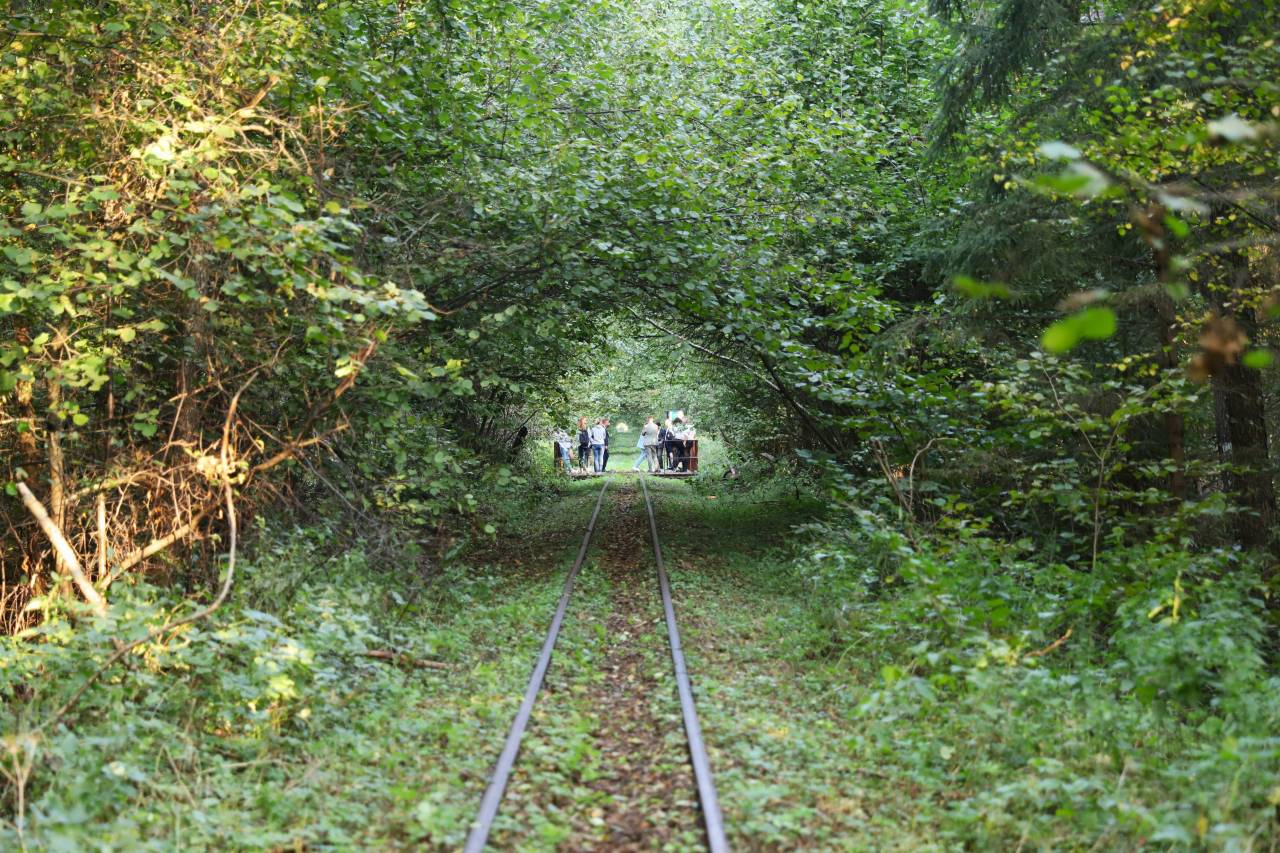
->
663 473 1280 850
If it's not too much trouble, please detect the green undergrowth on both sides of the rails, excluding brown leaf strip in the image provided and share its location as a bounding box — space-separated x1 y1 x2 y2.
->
10 474 1280 850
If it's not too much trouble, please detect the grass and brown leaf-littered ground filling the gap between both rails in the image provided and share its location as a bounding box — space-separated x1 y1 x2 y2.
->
494 480 700 850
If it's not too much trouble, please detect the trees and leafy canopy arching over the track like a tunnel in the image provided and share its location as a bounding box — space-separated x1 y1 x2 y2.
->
0 0 1277 604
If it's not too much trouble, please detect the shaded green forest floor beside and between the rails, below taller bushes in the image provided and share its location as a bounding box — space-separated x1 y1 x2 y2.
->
0 468 1277 850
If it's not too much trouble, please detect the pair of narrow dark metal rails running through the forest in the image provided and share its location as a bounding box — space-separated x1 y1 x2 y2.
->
463 476 728 853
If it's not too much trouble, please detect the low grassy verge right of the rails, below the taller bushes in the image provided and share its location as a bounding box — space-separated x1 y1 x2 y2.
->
657 473 1280 850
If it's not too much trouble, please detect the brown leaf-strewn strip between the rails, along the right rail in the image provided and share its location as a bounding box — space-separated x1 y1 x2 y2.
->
576 484 700 850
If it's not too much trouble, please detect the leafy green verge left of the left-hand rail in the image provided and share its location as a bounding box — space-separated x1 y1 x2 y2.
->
0 473 609 850
